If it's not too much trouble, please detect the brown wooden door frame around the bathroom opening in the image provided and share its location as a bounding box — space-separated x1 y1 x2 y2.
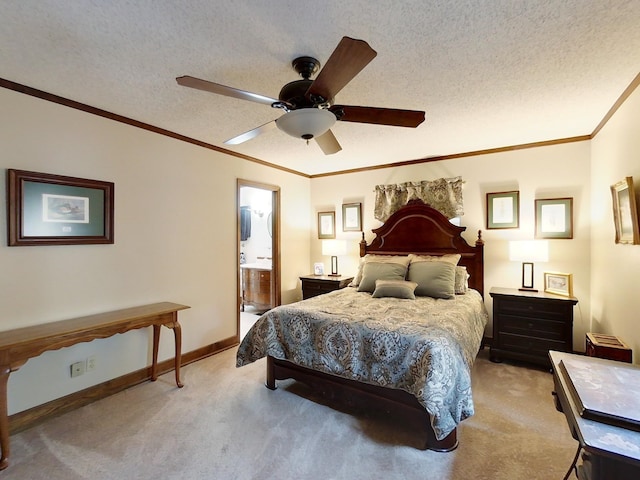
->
236 178 282 341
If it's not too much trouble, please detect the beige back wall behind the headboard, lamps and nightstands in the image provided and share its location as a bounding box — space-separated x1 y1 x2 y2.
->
309 141 591 350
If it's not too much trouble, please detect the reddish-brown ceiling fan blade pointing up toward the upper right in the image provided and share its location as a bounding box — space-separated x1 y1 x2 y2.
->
305 37 377 101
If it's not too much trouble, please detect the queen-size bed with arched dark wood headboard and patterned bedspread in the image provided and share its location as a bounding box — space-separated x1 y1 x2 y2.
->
236 201 487 451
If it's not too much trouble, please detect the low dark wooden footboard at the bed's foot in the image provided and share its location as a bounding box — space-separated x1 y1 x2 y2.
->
266 356 458 452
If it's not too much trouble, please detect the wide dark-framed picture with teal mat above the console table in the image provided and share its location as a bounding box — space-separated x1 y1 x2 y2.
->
7 169 114 247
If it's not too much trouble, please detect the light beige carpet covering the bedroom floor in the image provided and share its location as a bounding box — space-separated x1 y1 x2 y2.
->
0 349 577 480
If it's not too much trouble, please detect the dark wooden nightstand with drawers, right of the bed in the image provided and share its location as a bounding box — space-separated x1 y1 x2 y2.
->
489 287 578 367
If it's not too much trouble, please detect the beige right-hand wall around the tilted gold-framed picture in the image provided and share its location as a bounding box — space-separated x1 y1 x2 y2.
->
591 84 640 363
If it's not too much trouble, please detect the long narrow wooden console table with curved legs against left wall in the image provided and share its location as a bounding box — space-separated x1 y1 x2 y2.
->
0 302 189 470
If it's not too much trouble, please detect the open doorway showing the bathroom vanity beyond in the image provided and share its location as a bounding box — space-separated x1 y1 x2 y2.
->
236 179 281 340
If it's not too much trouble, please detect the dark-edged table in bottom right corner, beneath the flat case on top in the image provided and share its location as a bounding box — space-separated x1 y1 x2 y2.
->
549 351 640 480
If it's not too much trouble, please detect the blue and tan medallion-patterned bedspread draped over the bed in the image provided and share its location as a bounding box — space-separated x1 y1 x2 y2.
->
236 287 487 440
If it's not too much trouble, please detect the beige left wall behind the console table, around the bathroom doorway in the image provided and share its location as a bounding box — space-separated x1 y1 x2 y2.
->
0 89 311 413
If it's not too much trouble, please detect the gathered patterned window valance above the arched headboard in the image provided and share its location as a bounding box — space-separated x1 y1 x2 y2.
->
374 177 464 222
